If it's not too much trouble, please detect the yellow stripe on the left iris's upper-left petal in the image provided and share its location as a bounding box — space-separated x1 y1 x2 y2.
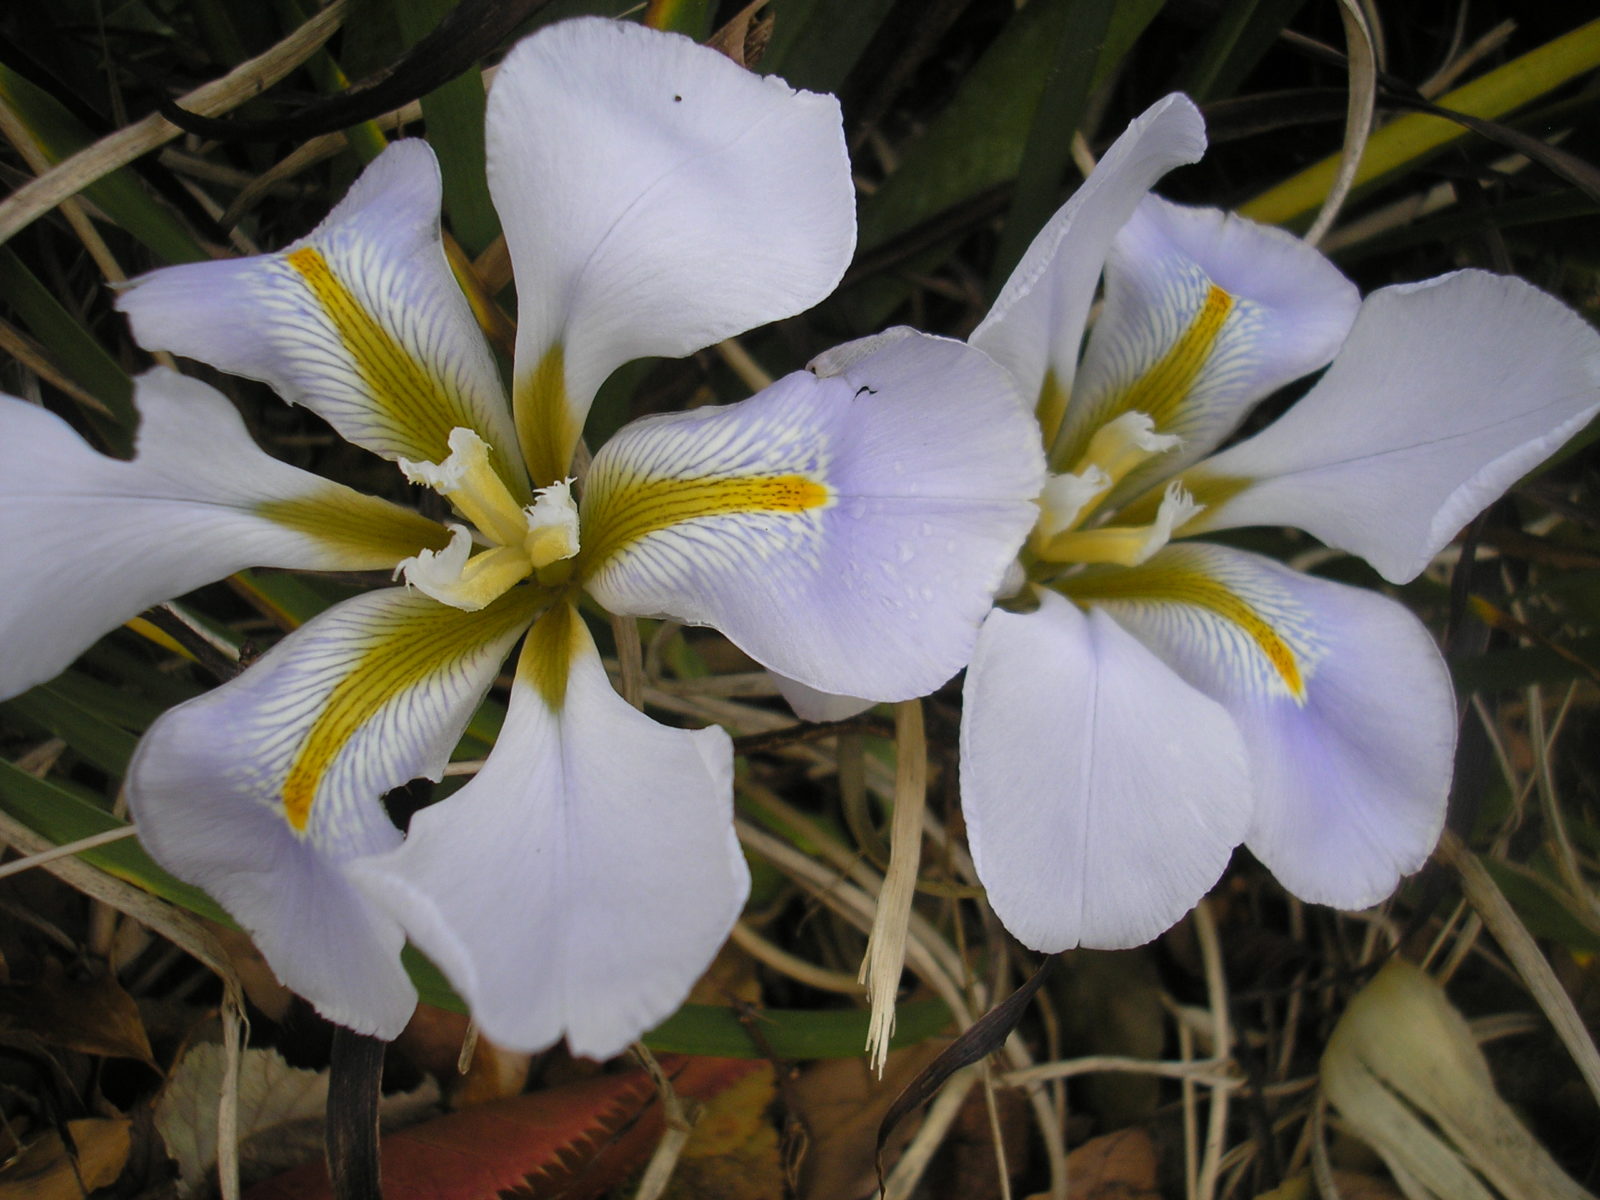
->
285 246 515 478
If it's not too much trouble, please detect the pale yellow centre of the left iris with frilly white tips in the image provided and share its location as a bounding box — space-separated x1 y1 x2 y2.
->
395 427 578 613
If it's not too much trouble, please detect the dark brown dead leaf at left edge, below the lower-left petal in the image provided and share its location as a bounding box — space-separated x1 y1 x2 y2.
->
0 960 155 1067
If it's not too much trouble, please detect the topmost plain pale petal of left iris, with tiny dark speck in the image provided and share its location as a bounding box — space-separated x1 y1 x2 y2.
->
486 18 856 485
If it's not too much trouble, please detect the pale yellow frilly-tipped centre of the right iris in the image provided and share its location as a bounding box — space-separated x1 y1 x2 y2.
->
1030 413 1203 566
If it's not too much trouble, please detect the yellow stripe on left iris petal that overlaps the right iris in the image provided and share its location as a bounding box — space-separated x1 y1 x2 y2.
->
579 475 834 574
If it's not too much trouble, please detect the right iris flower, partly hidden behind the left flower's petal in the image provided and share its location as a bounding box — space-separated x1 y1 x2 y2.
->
962 96 1600 950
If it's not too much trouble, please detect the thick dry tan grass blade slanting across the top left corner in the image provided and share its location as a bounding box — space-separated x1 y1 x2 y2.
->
0 0 347 245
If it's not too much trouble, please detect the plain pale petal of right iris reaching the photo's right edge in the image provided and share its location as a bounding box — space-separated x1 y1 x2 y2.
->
1184 270 1600 582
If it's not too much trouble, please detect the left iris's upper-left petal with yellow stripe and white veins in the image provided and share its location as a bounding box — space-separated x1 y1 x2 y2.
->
117 141 526 488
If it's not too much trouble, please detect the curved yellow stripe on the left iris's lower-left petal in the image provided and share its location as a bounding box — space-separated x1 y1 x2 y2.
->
283 587 549 834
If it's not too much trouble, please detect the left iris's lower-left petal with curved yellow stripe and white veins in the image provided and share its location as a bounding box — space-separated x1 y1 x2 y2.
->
126 589 533 1038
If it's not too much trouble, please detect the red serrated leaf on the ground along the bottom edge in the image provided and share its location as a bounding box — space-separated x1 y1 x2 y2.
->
245 1058 762 1200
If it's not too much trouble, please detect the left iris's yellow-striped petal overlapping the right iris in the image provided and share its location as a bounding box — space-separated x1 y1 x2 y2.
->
579 333 1043 701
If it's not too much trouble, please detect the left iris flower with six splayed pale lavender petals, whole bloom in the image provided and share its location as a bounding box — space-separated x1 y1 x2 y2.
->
0 19 1043 1056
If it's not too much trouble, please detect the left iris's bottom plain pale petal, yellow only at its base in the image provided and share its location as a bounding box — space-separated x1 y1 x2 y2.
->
350 605 749 1058
